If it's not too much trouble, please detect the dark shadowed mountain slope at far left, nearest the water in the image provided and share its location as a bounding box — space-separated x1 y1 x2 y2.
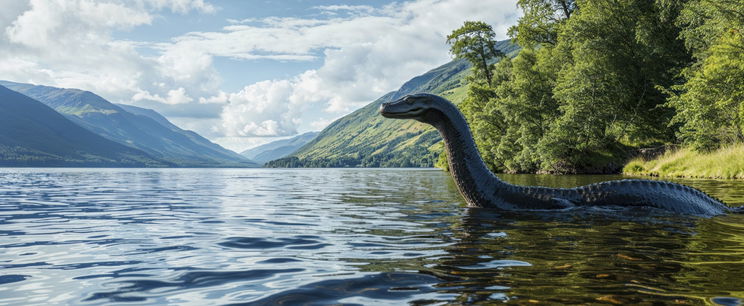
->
0 86 167 167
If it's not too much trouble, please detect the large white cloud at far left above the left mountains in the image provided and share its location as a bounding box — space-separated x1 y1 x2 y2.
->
0 0 220 107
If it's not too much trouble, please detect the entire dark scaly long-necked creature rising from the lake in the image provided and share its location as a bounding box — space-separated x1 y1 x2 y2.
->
380 94 744 216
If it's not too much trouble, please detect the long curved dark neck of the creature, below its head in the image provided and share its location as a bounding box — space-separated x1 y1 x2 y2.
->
429 103 509 207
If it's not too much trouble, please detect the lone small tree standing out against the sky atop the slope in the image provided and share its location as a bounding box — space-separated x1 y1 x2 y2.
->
447 21 504 86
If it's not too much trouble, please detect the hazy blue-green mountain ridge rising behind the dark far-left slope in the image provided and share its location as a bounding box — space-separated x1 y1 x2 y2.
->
0 81 258 167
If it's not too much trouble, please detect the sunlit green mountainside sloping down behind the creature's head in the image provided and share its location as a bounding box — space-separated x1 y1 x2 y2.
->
266 40 519 167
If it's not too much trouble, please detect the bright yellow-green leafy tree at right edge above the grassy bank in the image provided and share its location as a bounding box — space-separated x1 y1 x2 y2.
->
668 0 744 151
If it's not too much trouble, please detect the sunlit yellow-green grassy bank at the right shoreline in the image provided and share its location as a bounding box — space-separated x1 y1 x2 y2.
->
623 144 744 179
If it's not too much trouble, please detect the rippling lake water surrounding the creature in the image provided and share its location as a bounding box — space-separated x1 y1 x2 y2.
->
0 168 744 305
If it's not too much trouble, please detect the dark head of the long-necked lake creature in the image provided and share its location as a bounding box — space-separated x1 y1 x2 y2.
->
380 94 450 123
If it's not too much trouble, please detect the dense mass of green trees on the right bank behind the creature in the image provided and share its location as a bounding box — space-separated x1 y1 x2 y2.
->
448 0 744 173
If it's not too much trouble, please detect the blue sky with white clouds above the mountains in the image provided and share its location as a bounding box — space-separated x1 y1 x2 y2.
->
0 0 519 152
